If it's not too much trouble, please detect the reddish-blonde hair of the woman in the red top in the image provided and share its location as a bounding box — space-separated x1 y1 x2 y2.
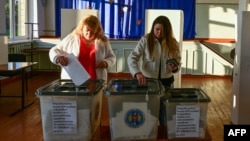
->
72 15 108 43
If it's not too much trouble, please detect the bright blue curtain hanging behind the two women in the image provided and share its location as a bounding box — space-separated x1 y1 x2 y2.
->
55 0 196 39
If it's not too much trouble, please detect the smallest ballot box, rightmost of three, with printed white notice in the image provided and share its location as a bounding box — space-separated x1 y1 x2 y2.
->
165 88 211 139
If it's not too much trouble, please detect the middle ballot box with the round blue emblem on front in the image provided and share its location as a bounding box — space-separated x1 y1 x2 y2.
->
105 79 162 141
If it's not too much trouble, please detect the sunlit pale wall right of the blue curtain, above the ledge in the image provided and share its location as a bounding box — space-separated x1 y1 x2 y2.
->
196 3 238 39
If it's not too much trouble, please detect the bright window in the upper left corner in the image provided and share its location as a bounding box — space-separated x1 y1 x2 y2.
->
5 0 27 40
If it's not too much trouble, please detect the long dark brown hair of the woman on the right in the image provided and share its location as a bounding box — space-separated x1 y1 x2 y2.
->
146 16 180 60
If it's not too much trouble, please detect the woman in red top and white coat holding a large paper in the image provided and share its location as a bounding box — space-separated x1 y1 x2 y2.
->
49 15 116 82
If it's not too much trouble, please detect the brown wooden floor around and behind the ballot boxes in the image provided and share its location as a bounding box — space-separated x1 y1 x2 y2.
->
0 72 232 141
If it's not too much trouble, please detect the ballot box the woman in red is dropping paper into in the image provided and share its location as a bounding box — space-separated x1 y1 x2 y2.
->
36 79 104 141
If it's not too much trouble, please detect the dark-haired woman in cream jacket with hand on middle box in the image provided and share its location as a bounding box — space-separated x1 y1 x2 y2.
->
127 16 181 125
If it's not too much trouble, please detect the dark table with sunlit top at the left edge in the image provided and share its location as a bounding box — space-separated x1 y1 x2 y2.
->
0 62 37 116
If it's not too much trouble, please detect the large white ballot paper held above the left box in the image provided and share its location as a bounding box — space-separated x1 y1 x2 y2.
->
63 54 90 86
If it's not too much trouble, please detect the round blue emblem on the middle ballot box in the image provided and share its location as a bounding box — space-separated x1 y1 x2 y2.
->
125 109 145 128
